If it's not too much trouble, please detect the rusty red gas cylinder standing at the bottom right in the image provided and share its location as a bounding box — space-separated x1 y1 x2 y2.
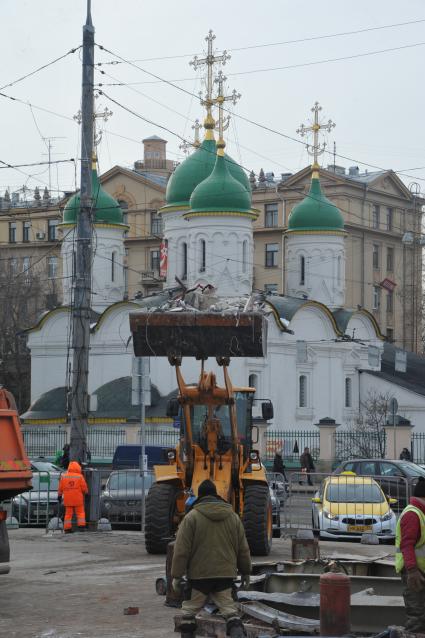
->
320 571 351 636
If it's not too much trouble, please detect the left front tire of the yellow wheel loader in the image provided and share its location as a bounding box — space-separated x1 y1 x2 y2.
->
145 483 177 554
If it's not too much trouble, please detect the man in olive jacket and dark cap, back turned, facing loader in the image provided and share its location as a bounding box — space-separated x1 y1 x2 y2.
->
171 480 251 638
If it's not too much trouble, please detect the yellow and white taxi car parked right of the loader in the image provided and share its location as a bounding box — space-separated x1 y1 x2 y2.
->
311 474 397 540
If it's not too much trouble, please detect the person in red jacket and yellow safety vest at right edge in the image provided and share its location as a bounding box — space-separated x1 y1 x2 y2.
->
395 477 425 634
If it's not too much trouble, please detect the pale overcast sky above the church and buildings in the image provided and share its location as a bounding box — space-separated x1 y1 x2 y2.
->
0 0 425 200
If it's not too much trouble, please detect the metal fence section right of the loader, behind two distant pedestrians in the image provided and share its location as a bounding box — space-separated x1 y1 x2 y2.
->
265 430 320 463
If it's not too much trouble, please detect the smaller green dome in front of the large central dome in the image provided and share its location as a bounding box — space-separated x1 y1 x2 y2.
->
188 155 253 215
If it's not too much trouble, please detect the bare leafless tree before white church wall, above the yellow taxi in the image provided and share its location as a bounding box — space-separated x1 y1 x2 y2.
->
336 390 392 460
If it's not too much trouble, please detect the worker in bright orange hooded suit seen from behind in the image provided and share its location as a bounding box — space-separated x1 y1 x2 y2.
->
58 461 89 534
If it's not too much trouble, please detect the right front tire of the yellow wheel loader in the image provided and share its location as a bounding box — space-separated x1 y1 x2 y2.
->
243 484 273 556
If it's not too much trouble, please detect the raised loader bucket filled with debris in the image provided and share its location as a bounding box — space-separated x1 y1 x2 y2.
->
130 312 267 359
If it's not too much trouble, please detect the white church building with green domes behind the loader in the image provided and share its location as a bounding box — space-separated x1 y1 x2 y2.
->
22 118 425 462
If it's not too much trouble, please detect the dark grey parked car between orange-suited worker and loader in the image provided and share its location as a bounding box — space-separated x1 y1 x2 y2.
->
100 470 155 525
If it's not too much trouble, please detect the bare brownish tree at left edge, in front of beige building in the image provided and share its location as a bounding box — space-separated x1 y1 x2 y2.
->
0 258 56 412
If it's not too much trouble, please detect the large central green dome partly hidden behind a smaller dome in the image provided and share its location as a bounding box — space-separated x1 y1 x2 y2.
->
164 139 250 210
